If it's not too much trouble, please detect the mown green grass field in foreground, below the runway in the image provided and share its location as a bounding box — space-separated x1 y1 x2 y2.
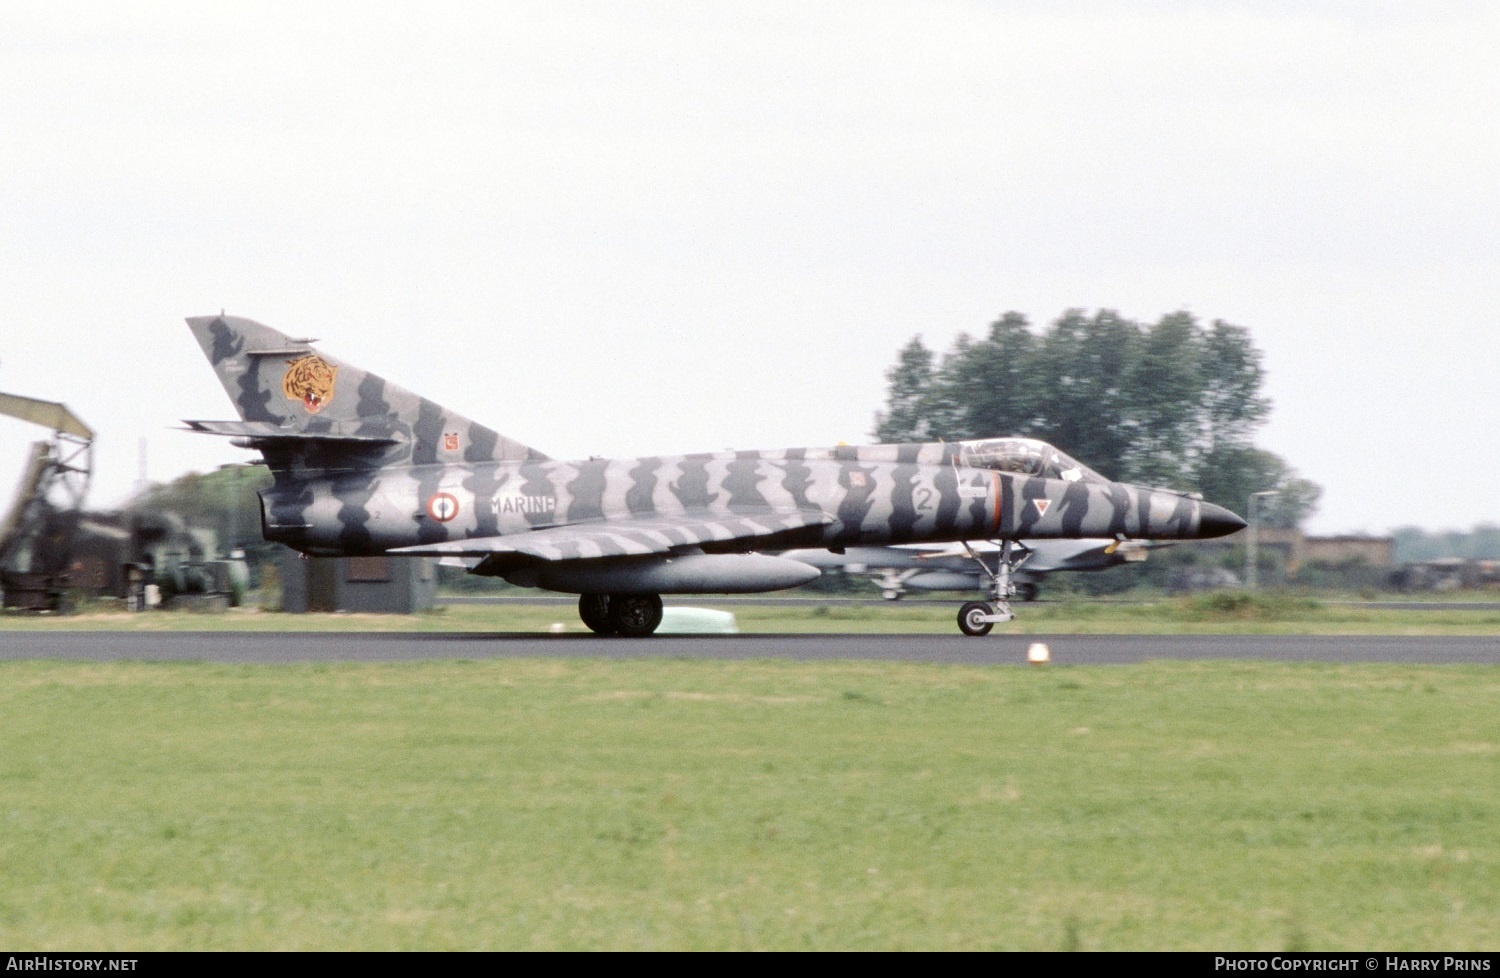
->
0 660 1500 951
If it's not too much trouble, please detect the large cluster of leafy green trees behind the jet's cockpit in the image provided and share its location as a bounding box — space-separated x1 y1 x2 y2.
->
875 309 1322 527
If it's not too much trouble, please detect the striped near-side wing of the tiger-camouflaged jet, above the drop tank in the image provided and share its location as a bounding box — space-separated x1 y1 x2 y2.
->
389 510 834 561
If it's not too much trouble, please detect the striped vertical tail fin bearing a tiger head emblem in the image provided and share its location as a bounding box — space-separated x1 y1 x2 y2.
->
188 315 548 465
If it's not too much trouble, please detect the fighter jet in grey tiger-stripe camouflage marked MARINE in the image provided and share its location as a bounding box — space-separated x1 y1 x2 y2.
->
186 315 1245 638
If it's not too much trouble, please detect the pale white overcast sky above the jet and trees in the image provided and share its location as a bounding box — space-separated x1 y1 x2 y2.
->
0 0 1500 533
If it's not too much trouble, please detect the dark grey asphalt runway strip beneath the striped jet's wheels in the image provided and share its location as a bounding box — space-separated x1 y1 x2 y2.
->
0 632 1500 666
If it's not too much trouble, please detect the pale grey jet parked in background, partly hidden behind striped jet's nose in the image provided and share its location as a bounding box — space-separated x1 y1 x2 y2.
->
782 540 1170 602
